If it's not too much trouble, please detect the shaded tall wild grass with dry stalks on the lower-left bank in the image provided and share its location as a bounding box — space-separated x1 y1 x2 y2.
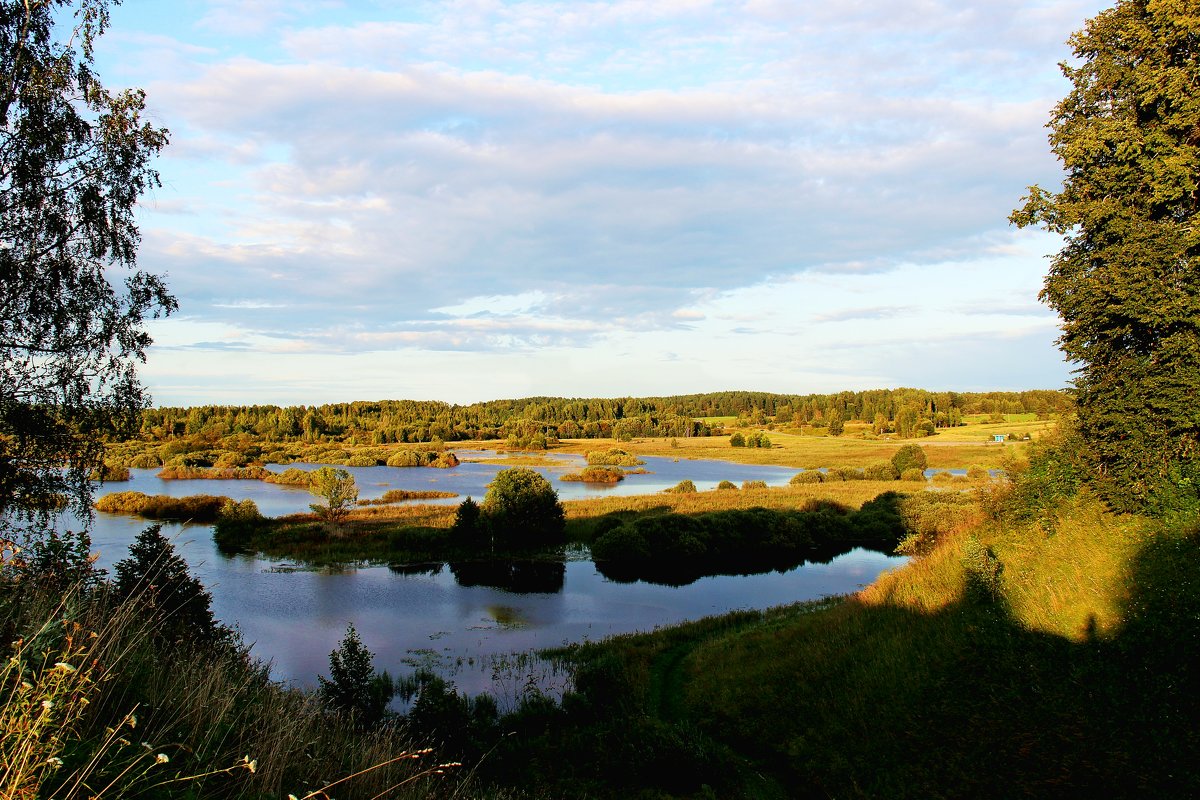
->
0 542 468 800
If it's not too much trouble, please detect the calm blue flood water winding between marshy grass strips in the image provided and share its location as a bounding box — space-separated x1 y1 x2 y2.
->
84 453 902 702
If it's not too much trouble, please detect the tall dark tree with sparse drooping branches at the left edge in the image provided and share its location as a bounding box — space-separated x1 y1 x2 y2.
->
0 0 175 535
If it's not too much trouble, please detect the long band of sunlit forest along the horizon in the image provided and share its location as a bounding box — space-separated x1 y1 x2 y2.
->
133 389 1072 446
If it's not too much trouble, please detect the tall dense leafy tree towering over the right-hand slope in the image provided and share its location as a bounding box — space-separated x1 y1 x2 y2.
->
1010 0 1200 510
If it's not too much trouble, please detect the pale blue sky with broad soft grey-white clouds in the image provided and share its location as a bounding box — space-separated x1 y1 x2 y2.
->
96 0 1106 405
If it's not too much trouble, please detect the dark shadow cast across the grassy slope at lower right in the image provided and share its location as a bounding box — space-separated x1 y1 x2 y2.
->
678 522 1200 798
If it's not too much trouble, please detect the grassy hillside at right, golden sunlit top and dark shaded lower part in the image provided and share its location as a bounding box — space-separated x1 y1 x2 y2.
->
552 495 1200 798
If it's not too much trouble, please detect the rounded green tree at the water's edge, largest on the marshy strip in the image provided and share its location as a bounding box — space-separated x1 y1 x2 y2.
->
482 468 566 547
